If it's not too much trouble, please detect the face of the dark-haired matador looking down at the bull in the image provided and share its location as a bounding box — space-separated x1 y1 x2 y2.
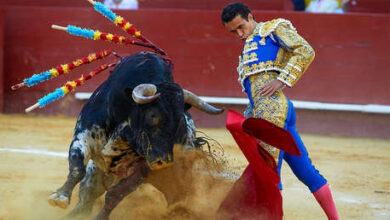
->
224 13 257 41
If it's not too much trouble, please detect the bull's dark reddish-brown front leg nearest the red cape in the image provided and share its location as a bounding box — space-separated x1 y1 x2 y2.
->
95 158 150 220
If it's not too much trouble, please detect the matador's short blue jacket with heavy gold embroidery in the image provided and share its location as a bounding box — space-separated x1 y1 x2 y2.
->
237 18 315 88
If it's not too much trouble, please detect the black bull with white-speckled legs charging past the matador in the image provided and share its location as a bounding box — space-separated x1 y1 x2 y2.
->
49 52 222 219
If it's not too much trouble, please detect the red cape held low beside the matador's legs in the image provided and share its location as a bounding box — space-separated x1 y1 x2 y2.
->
217 109 301 220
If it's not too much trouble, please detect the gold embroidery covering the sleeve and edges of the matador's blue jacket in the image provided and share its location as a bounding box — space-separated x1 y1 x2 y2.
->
239 18 314 87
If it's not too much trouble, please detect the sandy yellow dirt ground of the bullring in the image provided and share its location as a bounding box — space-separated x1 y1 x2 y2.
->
0 115 390 220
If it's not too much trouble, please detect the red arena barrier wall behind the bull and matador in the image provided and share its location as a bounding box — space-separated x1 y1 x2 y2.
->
4 7 390 136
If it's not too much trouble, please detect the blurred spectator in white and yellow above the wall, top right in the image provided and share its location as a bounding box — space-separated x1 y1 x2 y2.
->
305 0 349 13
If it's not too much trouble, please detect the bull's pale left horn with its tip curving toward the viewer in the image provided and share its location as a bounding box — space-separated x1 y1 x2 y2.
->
132 84 160 105
